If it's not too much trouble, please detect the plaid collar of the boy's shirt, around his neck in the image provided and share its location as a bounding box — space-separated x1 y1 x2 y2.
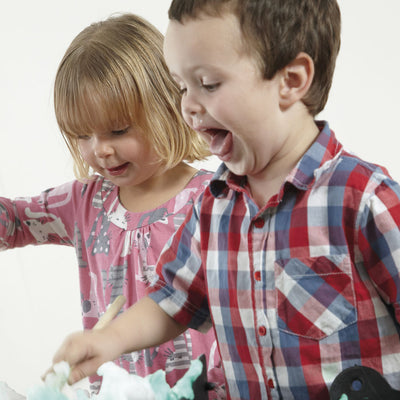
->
210 121 342 197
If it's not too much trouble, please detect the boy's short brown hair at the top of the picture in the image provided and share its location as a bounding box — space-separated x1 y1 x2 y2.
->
168 0 341 116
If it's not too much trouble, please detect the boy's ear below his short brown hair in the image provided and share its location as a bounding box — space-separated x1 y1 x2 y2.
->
280 52 314 109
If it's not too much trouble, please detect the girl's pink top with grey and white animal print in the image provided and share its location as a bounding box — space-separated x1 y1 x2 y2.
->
0 170 224 399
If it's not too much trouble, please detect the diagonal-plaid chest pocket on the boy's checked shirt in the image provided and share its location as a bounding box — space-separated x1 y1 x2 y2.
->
275 254 357 340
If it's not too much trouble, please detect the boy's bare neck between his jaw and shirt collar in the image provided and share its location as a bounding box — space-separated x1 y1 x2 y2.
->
247 119 319 209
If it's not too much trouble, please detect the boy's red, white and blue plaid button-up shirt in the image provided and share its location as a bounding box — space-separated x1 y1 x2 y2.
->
150 123 400 400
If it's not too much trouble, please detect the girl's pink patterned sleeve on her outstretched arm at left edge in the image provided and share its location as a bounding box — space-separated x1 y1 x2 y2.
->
0 181 81 250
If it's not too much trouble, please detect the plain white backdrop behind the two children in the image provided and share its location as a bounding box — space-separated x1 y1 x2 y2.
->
0 0 400 393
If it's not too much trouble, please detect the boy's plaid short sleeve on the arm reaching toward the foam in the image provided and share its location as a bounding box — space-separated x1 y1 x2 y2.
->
148 198 212 332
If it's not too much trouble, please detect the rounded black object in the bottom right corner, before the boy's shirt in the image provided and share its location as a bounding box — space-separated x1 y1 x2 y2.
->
329 365 400 400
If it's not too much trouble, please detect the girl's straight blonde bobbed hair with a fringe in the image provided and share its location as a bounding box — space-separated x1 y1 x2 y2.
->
54 14 209 179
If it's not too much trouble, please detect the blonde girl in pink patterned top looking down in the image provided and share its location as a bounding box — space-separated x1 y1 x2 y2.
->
0 14 223 398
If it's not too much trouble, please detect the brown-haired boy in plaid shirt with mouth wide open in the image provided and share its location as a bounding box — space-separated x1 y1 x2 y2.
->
55 0 400 400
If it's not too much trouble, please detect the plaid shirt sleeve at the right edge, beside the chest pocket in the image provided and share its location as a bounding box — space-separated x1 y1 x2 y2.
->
356 173 400 324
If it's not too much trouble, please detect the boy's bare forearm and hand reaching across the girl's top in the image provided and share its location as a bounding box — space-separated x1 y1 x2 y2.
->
53 297 187 384
